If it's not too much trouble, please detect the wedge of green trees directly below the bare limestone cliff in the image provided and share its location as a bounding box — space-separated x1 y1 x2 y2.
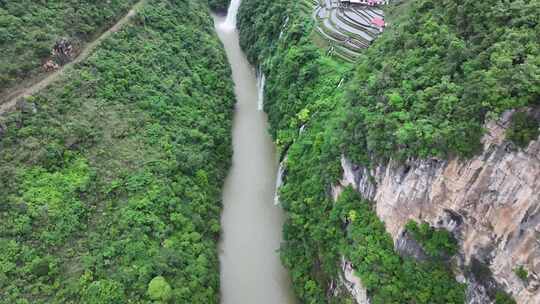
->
331 187 465 304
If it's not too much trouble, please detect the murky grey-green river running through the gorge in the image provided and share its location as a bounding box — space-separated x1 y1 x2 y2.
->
215 0 295 304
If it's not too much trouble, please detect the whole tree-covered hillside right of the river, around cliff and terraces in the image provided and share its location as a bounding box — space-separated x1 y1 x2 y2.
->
239 0 540 303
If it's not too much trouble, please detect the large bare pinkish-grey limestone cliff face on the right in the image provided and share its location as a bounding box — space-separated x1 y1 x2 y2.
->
334 113 540 304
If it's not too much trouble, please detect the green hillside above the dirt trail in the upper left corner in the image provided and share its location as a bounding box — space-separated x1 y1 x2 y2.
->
0 0 136 92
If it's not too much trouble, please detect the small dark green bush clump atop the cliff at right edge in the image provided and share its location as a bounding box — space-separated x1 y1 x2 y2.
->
506 112 540 148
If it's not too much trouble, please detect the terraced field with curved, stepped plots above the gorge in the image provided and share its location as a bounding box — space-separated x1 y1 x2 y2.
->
313 0 384 61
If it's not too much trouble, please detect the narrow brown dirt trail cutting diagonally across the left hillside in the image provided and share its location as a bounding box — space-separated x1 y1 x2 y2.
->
0 0 146 115
